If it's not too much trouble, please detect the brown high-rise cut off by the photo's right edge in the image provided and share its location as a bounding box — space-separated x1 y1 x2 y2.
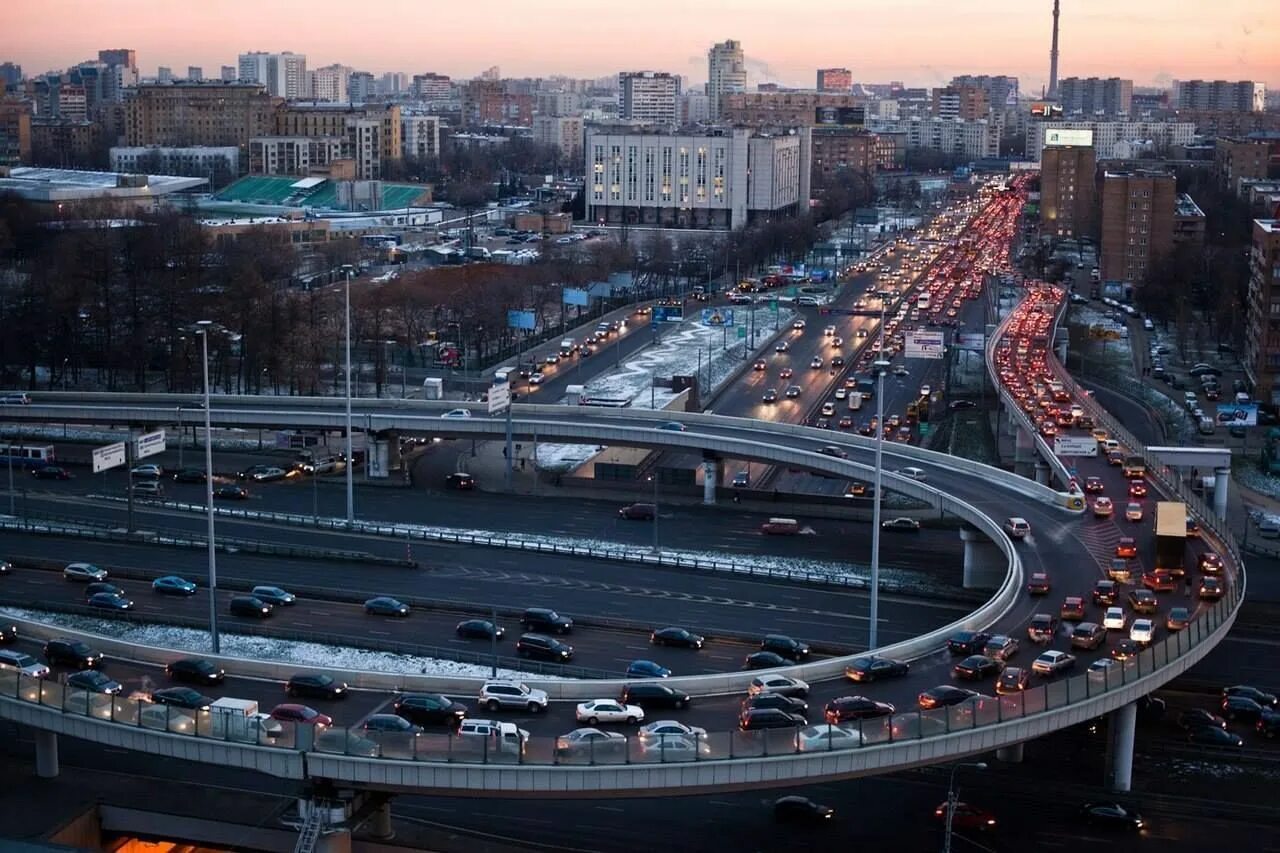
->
1243 219 1280 405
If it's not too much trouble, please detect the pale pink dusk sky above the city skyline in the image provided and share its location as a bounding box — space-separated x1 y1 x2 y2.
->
0 0 1280 92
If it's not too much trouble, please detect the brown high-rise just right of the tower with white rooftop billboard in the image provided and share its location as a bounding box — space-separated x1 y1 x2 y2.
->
1101 169 1178 286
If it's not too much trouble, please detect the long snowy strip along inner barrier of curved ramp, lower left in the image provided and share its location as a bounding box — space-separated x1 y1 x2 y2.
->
3 607 561 681
